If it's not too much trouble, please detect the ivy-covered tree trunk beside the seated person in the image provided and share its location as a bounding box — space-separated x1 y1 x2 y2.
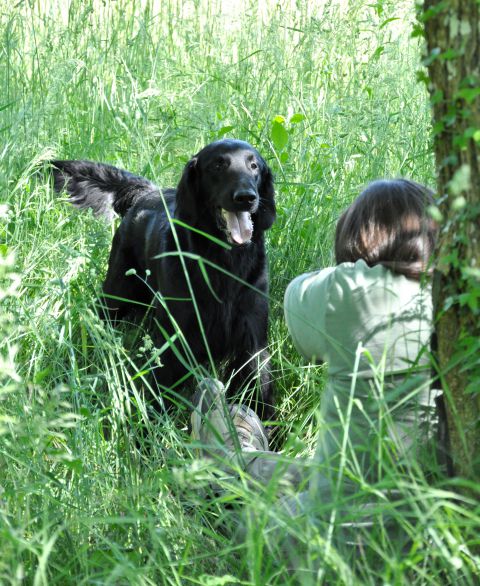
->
420 0 480 480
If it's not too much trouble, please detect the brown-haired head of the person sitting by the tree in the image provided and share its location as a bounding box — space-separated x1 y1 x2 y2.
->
335 179 438 279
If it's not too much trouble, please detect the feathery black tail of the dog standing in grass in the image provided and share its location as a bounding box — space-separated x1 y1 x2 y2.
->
52 161 158 220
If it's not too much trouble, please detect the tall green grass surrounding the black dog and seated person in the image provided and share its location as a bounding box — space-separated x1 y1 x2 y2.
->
0 0 480 586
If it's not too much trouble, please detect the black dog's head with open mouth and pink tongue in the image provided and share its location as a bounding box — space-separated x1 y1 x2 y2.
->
175 139 276 246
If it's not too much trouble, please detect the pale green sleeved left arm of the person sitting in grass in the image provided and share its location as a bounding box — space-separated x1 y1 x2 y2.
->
284 267 336 363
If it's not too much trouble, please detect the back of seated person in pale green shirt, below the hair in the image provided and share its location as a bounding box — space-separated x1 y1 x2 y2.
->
285 260 435 490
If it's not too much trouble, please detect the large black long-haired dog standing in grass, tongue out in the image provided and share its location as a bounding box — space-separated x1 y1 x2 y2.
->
53 140 276 417
